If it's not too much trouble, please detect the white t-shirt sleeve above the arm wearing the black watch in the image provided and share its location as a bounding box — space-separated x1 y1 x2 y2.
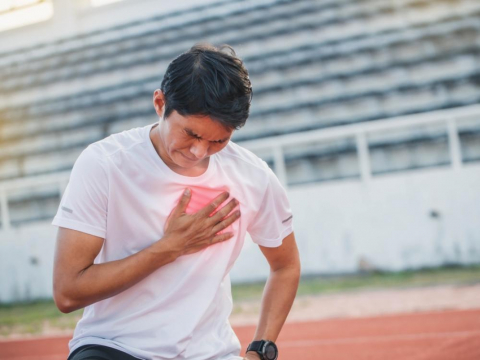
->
247 165 293 247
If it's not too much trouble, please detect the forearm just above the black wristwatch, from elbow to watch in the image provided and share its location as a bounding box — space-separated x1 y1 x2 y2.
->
253 266 300 341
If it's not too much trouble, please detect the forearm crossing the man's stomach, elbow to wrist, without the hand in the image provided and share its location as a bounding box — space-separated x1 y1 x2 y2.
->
59 241 178 312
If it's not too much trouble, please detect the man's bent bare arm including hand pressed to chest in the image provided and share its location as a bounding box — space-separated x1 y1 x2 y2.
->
53 192 240 313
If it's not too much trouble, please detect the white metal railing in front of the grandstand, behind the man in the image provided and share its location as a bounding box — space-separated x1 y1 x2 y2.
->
0 105 480 230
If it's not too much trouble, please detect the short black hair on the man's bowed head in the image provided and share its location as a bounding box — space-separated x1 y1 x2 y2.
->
161 44 252 129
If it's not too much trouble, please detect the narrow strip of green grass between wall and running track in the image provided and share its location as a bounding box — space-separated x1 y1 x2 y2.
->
0 265 480 337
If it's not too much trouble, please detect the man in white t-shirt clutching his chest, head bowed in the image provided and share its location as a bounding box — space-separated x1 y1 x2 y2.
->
52 45 300 360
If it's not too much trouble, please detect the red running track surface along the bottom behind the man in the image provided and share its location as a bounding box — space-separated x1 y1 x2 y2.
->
0 309 480 360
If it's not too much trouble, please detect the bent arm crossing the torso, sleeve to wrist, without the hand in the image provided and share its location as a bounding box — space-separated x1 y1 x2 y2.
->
53 228 176 313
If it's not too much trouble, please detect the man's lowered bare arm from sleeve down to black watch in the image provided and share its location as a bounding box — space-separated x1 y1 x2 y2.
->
246 232 300 359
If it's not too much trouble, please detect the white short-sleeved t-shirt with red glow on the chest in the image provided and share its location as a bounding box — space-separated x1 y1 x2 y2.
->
52 123 293 360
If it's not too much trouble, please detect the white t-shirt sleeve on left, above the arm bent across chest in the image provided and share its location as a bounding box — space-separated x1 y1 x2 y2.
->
52 146 108 239
